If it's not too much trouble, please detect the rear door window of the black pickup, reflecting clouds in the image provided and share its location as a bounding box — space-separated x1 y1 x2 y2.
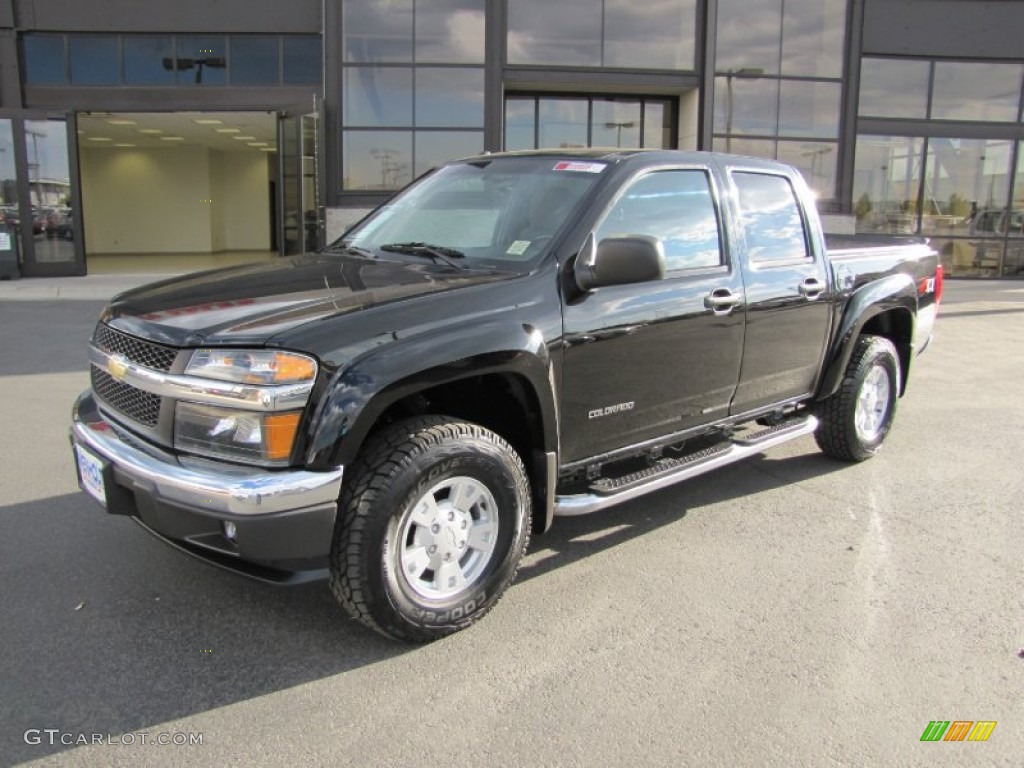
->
732 173 810 263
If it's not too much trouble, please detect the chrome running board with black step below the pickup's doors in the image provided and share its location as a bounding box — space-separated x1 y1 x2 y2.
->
555 416 818 517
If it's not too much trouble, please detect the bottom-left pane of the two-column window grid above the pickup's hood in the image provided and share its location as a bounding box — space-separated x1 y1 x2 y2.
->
342 131 413 189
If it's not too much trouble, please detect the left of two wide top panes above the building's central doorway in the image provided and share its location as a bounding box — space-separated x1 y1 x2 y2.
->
508 0 601 67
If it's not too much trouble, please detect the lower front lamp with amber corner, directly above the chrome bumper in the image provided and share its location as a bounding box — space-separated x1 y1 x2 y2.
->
174 402 302 466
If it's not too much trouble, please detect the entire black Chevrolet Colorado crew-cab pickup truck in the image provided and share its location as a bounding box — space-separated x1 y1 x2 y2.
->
72 151 942 641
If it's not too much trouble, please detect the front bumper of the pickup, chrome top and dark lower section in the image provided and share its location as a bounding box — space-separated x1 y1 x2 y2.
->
71 391 344 583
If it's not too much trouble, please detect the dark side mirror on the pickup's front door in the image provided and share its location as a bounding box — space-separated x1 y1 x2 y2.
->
572 232 665 291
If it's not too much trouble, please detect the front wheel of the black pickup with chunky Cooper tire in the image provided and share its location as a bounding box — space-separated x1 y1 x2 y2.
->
331 417 530 642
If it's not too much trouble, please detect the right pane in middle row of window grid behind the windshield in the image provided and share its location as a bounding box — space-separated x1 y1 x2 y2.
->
415 67 483 128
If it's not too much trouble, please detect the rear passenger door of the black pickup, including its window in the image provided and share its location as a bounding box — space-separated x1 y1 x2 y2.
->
730 169 831 414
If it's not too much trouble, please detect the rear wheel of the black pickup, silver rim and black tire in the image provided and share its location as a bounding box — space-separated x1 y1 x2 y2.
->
814 336 900 462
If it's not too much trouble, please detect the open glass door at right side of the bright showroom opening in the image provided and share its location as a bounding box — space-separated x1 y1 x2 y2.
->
278 113 324 256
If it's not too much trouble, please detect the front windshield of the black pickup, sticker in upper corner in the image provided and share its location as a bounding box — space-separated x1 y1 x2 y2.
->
337 157 607 269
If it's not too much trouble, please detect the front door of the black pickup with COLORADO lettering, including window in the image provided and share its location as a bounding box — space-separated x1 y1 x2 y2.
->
562 167 743 462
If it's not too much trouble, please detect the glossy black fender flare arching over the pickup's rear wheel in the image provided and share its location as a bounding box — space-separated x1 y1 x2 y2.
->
815 273 918 400
